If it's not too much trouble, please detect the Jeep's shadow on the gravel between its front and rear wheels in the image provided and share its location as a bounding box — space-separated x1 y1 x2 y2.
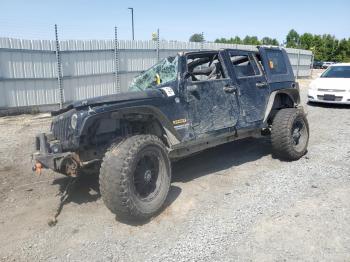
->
173 137 271 182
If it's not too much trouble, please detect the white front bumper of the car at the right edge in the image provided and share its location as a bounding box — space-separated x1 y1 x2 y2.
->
307 89 350 104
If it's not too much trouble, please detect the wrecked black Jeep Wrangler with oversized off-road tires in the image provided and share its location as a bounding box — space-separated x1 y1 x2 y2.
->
34 47 309 219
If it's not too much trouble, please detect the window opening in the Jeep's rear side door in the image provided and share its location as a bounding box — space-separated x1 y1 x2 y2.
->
230 53 261 78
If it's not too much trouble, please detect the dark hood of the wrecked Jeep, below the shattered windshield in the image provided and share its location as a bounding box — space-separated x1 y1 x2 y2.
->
51 89 164 116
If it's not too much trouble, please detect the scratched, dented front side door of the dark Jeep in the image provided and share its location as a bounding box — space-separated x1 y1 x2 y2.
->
184 53 239 137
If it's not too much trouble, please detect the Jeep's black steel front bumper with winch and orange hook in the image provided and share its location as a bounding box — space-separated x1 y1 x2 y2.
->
33 133 80 177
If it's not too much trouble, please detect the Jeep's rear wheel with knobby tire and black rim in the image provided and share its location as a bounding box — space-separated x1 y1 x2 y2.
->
271 108 309 161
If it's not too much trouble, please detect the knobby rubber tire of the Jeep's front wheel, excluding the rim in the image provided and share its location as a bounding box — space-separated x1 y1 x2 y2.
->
99 135 171 220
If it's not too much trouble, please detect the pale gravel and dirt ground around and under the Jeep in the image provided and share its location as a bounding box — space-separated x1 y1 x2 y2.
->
0 70 350 261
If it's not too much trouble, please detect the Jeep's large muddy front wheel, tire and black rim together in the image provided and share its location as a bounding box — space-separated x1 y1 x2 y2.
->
100 135 171 220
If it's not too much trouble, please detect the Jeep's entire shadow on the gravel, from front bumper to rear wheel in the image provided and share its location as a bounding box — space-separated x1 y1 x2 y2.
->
53 137 271 226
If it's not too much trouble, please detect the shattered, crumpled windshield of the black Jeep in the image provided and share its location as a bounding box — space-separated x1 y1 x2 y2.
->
129 56 178 91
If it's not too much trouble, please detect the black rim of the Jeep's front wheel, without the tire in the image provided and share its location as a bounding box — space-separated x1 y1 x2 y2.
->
134 151 162 201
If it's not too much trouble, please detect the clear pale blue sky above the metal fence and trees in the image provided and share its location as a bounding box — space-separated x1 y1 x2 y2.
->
0 0 350 41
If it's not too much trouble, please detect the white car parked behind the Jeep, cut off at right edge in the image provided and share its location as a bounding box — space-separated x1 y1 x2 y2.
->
308 63 350 104
